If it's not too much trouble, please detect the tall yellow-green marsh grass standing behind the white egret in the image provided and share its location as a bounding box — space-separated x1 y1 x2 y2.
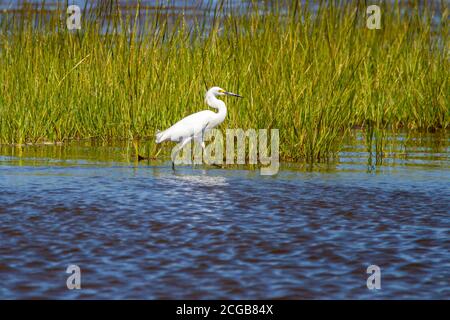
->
0 1 450 162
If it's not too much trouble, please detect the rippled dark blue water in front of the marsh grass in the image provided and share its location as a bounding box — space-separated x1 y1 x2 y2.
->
0 132 450 299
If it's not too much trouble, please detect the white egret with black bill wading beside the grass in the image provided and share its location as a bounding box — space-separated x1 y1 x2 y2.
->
156 87 242 169
